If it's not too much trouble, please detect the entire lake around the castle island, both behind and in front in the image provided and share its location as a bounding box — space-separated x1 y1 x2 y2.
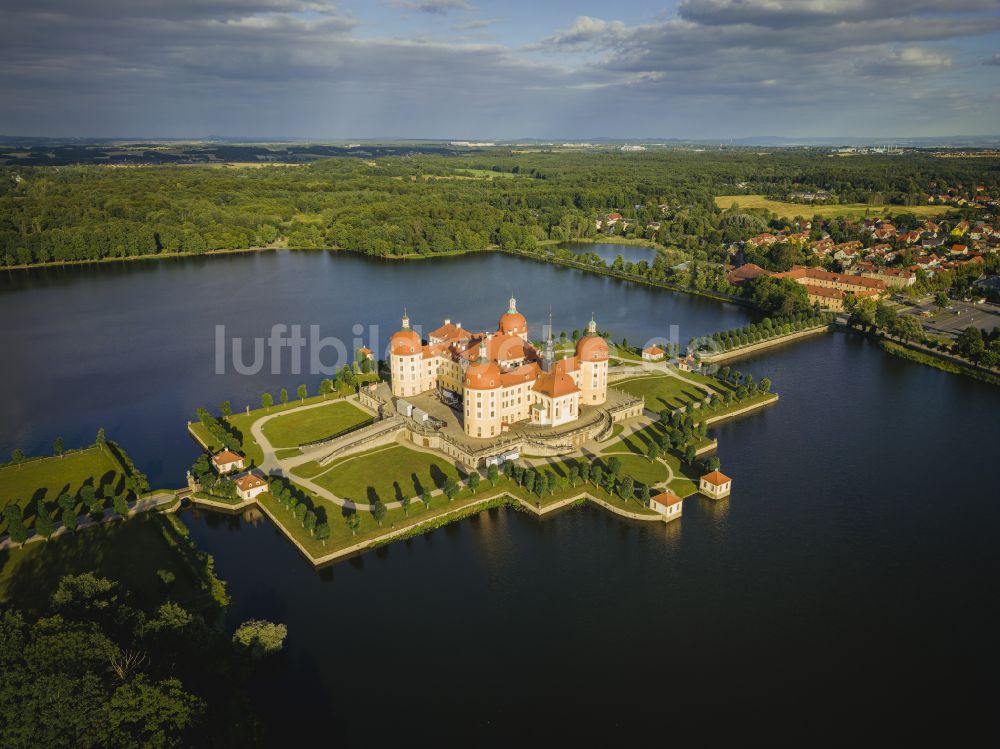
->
0 252 1000 745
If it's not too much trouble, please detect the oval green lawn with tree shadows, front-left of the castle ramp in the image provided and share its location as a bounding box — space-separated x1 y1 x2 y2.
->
306 444 461 503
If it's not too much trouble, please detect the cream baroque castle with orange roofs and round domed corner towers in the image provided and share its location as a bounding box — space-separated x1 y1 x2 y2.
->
389 297 608 438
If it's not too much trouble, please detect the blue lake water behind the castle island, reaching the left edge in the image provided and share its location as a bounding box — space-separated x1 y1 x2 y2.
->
0 252 749 486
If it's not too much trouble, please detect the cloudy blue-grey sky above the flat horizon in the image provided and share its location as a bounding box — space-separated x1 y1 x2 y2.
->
0 0 1000 140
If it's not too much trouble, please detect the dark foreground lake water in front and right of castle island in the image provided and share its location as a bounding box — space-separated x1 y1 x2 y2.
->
182 333 1000 744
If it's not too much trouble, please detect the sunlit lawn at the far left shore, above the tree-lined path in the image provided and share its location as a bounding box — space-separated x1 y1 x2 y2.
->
0 447 125 534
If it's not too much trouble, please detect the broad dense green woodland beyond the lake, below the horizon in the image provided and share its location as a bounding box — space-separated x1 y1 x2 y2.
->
0 149 1000 265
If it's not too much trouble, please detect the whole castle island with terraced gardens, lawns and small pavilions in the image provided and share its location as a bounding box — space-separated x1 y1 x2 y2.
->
186 297 778 566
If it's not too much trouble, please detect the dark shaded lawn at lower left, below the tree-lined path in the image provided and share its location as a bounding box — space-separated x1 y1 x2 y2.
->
0 513 211 609
